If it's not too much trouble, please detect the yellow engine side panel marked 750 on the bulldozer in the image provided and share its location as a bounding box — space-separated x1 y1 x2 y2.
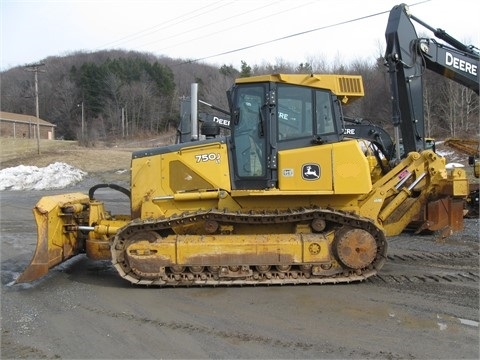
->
131 141 230 218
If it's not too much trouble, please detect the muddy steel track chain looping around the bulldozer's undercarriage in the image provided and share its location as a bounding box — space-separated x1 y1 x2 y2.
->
111 207 387 286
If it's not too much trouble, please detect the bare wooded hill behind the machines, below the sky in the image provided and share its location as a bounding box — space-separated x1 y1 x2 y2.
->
0 50 479 144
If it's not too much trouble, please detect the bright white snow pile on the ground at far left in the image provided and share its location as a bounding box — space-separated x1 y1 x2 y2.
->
0 162 87 191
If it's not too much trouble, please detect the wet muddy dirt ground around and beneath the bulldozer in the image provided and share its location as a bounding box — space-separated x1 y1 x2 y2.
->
0 138 480 359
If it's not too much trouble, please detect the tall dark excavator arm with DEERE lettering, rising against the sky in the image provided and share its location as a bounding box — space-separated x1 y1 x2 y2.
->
385 4 480 155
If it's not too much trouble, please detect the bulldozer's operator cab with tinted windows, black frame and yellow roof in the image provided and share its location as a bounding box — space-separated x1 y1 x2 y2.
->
228 74 363 189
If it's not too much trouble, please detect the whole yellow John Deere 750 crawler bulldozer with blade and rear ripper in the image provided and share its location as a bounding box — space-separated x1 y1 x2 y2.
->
17 4 478 286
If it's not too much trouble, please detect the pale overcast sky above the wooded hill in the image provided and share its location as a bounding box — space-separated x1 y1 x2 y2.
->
0 0 480 71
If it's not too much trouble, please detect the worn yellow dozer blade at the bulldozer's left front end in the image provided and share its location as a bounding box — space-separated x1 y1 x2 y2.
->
16 193 89 283
